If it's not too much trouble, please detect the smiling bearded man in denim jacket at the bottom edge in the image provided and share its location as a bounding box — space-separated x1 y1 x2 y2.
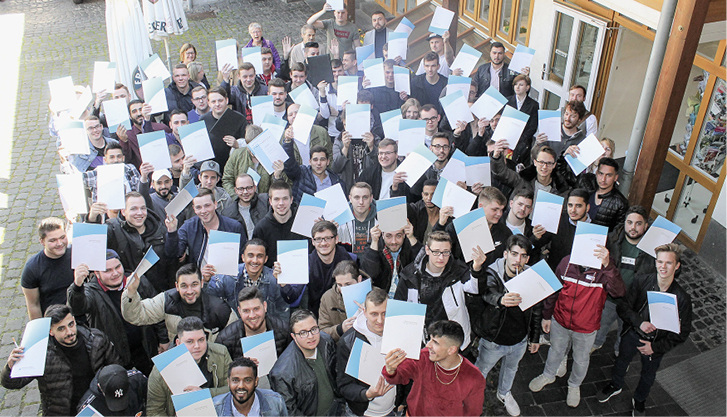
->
212 357 288 417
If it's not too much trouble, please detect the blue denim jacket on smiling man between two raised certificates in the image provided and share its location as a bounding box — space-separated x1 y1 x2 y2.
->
207 263 290 323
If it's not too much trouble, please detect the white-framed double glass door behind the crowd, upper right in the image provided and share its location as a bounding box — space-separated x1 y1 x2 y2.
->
540 4 606 110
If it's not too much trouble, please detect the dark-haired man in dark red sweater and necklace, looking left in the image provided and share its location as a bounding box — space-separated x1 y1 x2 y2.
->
381 320 486 416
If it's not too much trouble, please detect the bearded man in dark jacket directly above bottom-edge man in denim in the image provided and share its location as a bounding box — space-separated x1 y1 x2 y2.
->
217 288 292 362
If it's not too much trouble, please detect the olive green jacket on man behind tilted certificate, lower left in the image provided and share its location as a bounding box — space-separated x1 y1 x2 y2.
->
146 343 232 416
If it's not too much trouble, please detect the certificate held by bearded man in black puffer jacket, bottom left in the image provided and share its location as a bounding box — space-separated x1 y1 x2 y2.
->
10 316 52 378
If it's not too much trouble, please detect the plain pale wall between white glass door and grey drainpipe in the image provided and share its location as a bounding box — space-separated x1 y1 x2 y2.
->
598 27 653 158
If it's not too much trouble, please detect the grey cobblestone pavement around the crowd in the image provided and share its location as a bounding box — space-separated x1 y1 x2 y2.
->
0 0 725 415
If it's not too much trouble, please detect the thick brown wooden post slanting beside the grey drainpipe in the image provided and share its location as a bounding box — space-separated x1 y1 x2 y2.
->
629 0 709 207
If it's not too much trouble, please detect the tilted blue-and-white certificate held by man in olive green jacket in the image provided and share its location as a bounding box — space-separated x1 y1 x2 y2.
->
151 343 207 395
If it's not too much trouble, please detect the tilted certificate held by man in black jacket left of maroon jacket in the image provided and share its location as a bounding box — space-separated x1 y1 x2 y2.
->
505 259 563 311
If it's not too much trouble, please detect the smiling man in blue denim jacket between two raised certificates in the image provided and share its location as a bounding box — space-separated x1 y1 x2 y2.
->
207 238 290 322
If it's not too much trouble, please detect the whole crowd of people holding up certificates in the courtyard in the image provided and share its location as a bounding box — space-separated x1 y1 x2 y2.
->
5 4 691 416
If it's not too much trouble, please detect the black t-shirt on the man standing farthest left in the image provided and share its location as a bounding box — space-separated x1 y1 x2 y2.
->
20 247 73 314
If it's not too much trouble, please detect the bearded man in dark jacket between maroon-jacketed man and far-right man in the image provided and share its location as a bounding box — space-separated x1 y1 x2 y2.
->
593 206 656 353
